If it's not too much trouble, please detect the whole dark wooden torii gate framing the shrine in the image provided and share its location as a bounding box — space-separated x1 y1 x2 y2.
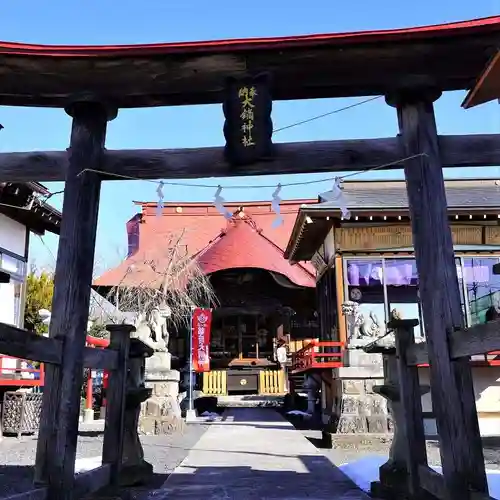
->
0 16 500 500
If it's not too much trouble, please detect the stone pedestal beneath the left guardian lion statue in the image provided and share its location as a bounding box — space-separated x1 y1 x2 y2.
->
139 352 184 435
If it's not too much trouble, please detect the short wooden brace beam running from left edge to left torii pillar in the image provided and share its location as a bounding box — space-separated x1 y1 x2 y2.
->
0 323 62 364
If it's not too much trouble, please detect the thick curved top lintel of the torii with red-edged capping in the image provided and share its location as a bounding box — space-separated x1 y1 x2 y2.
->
0 16 500 108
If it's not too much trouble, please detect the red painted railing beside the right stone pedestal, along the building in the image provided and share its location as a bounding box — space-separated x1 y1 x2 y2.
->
292 340 344 373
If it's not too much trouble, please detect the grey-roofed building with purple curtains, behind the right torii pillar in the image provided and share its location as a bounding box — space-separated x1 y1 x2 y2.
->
285 179 500 435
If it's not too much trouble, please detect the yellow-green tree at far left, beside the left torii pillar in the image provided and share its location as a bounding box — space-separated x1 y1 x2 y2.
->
24 270 54 334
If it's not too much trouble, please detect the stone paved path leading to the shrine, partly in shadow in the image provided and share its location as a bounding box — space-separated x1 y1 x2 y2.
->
148 408 369 500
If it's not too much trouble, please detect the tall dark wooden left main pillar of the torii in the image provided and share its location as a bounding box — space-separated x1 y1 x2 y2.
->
35 102 116 500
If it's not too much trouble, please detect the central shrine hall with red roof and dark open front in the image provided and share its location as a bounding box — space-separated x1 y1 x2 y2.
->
94 200 318 396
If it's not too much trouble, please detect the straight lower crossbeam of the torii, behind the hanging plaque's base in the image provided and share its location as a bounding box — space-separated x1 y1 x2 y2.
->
0 134 500 182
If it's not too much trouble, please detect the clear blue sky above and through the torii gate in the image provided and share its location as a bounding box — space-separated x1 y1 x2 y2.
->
0 0 500 269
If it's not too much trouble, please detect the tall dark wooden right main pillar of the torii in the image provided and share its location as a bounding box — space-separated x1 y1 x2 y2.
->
387 90 487 500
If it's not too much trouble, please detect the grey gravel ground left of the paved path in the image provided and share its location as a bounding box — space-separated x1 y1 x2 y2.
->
0 424 208 500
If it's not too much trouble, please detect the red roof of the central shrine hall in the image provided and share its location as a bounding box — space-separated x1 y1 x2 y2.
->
94 200 317 287
